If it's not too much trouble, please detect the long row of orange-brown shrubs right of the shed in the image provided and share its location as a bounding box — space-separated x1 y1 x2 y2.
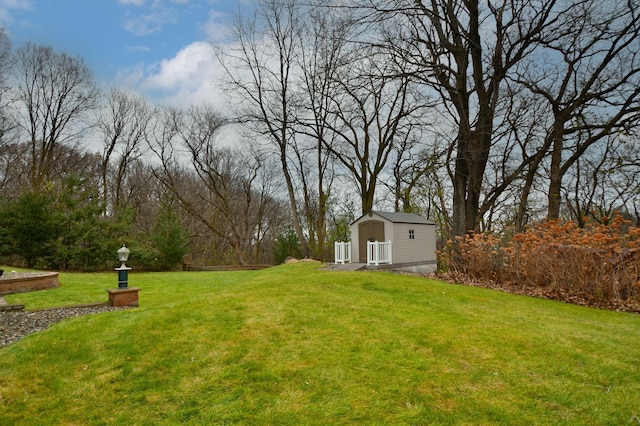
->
439 215 640 301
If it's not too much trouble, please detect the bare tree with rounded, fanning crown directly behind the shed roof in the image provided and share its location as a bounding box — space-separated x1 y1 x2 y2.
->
325 43 426 213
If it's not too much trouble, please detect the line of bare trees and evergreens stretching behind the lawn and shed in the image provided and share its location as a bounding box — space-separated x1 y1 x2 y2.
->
0 0 640 268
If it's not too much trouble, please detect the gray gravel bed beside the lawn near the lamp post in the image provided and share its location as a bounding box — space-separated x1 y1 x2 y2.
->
0 305 129 348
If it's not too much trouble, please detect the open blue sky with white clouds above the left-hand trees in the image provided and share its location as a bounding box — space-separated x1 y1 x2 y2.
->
0 0 242 106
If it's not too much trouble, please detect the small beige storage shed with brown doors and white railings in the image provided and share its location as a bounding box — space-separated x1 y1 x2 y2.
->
336 211 437 272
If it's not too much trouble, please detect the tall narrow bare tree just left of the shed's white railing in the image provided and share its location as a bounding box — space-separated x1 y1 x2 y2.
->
292 8 350 260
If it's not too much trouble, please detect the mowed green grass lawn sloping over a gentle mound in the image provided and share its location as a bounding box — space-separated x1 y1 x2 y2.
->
0 263 640 425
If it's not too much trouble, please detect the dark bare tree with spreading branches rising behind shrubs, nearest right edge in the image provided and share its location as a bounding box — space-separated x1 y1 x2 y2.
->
517 0 640 219
